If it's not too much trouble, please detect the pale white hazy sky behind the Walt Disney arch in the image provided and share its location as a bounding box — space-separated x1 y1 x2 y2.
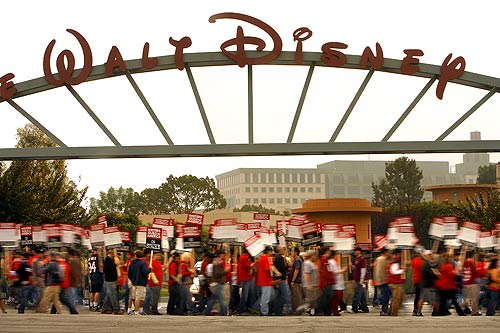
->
0 0 500 202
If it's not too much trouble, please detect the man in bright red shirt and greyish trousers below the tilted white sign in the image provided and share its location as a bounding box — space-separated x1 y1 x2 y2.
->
256 245 280 316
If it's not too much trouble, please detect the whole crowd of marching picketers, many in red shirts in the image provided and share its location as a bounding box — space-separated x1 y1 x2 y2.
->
0 246 500 316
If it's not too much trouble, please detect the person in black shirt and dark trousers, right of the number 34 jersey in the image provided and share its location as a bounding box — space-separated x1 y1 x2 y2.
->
101 250 123 314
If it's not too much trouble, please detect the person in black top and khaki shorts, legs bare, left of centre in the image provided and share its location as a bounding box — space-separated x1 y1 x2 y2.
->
128 250 151 314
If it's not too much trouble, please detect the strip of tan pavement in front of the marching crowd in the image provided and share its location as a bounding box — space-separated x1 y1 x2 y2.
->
0 307 500 333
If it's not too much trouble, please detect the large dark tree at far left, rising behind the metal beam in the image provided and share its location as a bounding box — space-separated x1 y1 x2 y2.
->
0 124 87 225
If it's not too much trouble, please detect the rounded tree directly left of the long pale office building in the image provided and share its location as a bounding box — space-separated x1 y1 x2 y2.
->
159 175 226 214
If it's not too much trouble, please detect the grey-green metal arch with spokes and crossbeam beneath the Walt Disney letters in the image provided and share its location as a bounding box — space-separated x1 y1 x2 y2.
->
0 51 500 160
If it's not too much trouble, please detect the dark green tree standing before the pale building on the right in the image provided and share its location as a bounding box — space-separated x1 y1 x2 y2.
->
372 157 424 208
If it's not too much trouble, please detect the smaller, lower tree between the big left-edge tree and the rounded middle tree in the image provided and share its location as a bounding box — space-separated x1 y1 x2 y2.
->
89 186 142 215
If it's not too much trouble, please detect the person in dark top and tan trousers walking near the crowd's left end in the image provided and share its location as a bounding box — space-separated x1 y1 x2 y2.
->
38 252 62 314
